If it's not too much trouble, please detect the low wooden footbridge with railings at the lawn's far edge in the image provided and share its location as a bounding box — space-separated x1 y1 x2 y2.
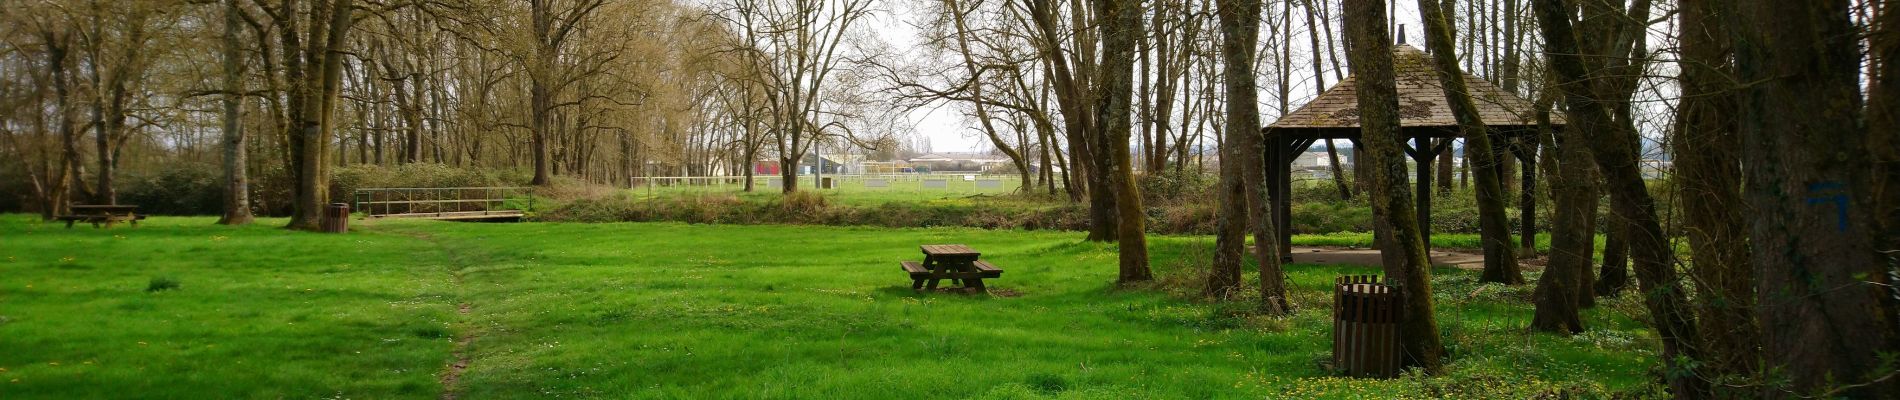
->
352 188 534 222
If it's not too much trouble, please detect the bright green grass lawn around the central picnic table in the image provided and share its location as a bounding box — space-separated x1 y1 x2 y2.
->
0 216 1657 398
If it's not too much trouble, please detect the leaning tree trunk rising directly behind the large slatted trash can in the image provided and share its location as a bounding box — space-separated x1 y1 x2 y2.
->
1345 0 1444 372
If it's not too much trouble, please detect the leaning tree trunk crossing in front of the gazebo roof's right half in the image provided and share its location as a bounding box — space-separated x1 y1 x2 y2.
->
1419 0 1524 284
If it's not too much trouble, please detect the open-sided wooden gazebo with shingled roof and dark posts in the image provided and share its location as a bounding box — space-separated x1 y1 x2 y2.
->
1262 44 1564 258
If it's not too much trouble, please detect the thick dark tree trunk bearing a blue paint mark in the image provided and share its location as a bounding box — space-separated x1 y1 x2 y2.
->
1731 0 1900 398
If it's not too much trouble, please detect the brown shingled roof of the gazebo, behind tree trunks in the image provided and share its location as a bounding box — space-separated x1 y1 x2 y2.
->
1267 44 1564 129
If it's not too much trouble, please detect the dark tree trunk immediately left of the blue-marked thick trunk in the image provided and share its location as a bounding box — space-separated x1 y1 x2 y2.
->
1670 0 1761 386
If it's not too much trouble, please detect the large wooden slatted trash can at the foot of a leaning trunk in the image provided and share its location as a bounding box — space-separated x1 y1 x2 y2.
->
1332 275 1400 377
